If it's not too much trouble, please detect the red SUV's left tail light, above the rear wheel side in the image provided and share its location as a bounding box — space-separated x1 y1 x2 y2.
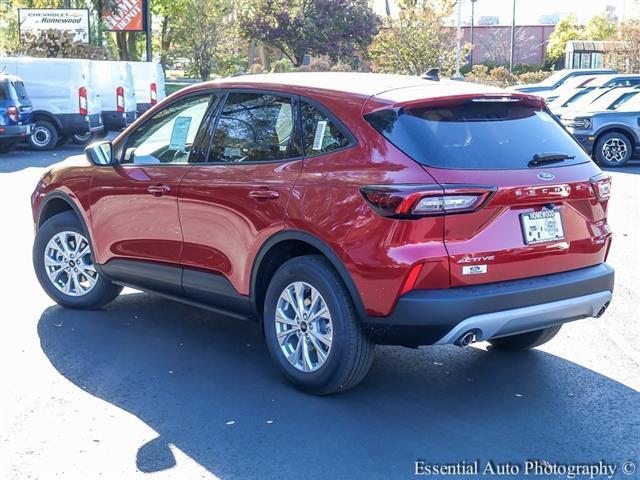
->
360 185 495 219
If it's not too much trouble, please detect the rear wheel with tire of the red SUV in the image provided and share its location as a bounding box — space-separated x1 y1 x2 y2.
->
263 255 375 395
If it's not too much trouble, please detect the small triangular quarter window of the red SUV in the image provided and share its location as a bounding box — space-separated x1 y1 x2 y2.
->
301 101 349 155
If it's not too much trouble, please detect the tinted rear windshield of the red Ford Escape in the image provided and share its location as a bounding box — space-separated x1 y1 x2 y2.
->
365 102 589 170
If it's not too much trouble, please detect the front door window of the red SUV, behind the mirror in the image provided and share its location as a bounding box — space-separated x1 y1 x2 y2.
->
120 94 211 165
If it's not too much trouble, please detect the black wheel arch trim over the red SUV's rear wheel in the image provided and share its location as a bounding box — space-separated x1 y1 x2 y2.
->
250 230 366 321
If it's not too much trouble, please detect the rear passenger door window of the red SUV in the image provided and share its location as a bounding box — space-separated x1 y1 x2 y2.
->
208 93 301 163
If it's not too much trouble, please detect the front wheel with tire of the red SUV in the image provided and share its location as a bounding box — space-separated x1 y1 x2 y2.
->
33 212 122 309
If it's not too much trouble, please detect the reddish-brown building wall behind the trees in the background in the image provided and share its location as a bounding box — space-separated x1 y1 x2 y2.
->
462 25 555 65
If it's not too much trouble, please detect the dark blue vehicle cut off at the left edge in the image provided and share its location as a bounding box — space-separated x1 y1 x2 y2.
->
0 74 33 153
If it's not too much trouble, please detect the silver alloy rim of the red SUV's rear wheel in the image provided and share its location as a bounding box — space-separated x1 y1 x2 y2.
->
275 282 333 372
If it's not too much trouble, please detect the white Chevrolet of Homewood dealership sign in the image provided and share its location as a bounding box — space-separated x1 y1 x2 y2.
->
18 8 89 43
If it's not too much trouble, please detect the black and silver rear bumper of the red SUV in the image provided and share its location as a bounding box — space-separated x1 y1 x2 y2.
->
364 263 614 347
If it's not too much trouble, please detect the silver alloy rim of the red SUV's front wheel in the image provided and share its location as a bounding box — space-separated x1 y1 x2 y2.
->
44 231 98 297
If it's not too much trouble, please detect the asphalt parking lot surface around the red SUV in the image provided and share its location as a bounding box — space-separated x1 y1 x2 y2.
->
0 147 640 479
